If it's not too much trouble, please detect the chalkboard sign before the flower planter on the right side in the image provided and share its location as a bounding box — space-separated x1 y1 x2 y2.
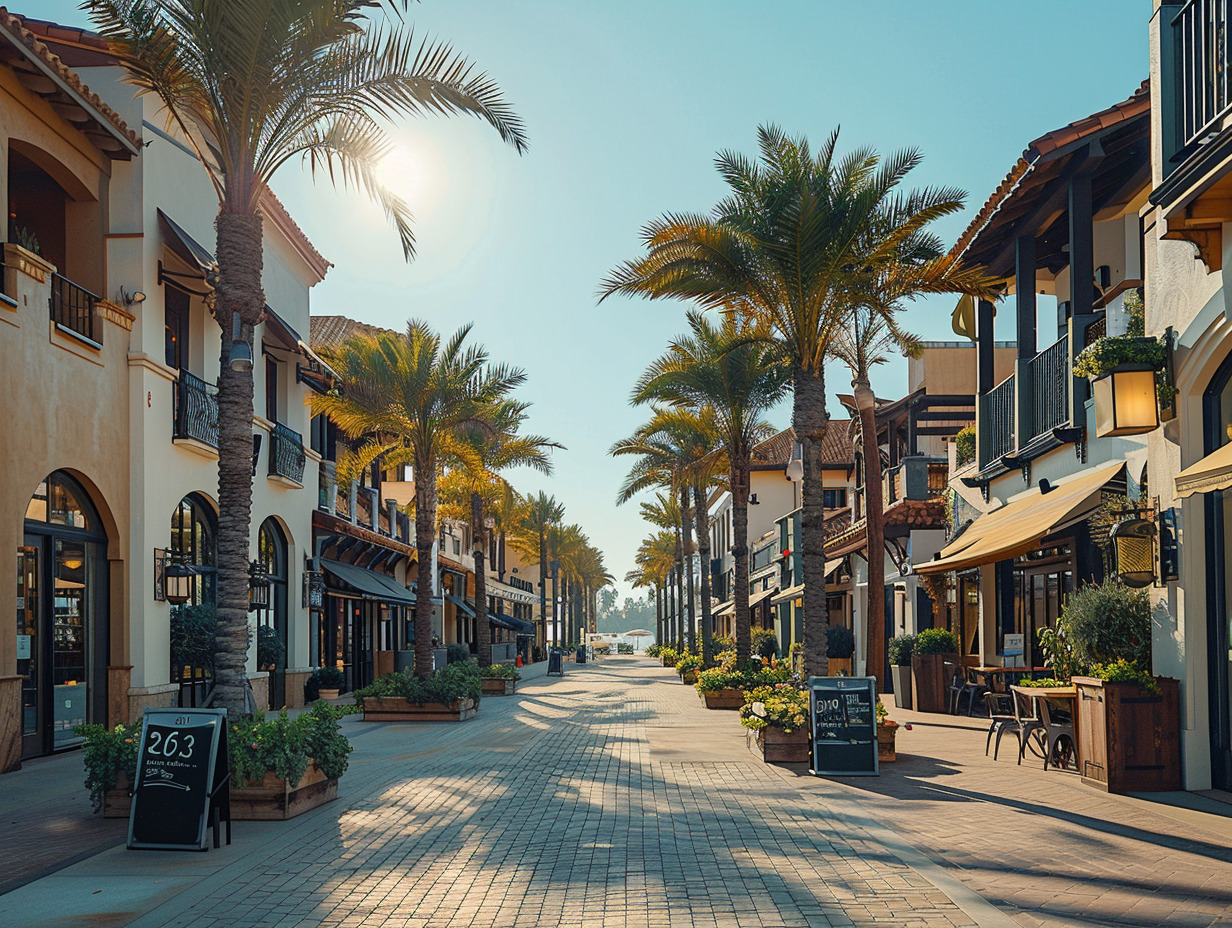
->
808 677 880 776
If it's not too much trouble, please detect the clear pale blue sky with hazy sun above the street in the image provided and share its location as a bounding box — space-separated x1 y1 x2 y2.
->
40 0 1152 596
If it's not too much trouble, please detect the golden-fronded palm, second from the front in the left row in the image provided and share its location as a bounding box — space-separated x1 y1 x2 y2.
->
310 320 526 677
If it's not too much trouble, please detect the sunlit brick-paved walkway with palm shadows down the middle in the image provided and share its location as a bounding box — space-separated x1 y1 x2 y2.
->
0 657 1232 928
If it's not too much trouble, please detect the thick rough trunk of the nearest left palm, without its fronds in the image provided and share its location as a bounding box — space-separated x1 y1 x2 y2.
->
214 206 265 715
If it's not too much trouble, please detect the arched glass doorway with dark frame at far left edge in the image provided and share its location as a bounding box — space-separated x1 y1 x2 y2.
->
17 471 110 757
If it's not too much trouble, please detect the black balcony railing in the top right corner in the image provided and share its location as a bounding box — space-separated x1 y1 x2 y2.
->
1172 0 1232 145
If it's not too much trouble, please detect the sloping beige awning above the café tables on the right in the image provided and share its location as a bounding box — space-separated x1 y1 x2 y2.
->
914 461 1128 573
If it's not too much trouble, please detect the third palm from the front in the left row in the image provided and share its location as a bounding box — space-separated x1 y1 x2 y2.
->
441 399 562 667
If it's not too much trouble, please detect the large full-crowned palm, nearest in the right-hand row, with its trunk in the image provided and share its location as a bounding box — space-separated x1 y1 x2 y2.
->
600 126 989 675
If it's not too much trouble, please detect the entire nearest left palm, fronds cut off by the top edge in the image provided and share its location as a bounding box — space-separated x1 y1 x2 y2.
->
84 0 526 712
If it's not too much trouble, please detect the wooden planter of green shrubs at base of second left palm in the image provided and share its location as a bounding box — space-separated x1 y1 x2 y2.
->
355 661 483 722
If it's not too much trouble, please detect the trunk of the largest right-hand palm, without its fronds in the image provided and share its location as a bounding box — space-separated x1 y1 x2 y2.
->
791 366 829 677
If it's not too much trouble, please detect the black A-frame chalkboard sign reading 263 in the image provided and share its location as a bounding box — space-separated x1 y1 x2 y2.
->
128 709 230 850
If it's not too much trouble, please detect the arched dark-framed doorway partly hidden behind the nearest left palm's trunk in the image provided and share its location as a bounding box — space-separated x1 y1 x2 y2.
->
169 493 218 706
